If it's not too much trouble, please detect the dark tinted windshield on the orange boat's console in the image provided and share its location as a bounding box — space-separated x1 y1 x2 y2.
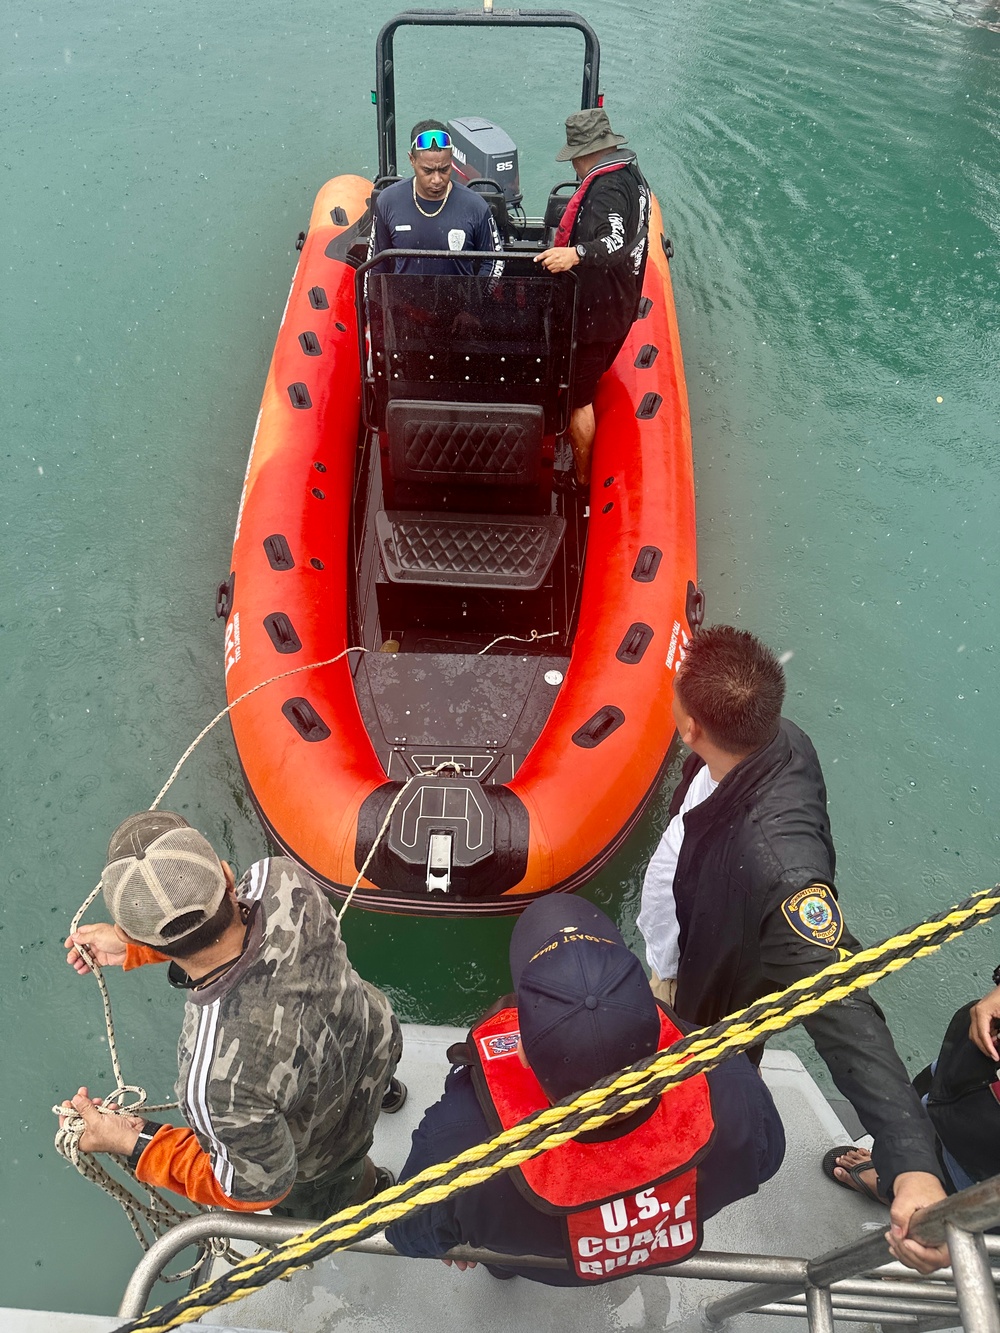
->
357 252 576 432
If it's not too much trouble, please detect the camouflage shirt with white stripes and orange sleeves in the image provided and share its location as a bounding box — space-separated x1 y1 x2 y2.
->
123 857 400 1212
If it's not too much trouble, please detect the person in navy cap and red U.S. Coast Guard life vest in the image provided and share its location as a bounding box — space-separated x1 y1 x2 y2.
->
387 893 784 1286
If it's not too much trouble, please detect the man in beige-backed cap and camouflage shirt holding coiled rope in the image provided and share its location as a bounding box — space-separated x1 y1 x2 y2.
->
64 810 405 1220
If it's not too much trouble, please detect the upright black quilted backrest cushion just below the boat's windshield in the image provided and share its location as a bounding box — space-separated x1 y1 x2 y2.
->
385 399 544 487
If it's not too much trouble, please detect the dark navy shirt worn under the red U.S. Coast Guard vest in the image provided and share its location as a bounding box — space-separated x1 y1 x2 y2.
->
385 1056 785 1286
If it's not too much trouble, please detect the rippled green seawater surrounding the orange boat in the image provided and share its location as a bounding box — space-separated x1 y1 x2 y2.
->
0 0 1000 1317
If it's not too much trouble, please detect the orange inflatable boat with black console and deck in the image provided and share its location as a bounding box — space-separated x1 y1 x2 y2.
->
217 11 701 916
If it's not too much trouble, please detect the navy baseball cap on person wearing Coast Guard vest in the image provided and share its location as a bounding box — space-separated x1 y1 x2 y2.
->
511 893 660 1101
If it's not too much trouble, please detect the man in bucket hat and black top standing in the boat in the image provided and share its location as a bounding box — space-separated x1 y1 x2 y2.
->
536 107 649 489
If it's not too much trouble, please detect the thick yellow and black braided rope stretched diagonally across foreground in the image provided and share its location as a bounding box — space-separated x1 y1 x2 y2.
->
117 885 1000 1333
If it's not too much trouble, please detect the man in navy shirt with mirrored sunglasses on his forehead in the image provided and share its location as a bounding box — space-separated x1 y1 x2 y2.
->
368 120 503 279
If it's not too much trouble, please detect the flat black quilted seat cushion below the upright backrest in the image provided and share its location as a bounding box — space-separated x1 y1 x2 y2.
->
375 509 565 592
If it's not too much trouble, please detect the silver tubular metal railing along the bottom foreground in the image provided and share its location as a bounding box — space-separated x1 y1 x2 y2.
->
119 1176 1000 1333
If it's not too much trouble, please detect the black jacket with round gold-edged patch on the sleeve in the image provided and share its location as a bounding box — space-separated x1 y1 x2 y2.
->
671 718 941 1192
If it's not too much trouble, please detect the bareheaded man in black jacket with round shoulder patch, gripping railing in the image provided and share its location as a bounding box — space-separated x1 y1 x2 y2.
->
639 625 947 1272
